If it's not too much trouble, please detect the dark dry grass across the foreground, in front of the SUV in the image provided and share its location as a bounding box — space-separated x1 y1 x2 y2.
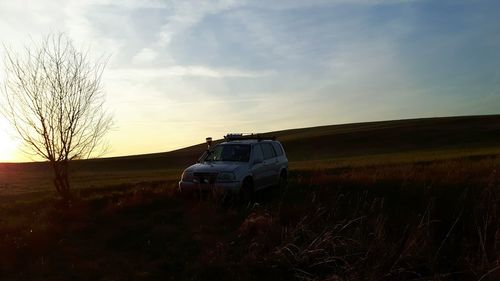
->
0 156 500 281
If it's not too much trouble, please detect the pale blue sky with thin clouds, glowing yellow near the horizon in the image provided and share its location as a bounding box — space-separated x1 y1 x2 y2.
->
0 0 500 161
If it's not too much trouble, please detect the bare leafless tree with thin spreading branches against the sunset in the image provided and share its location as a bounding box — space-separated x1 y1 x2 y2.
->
0 34 112 200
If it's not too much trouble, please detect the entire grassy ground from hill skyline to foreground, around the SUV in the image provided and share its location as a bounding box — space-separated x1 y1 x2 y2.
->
0 116 500 280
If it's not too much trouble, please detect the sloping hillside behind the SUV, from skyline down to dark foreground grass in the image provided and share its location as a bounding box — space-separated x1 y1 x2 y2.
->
0 115 500 194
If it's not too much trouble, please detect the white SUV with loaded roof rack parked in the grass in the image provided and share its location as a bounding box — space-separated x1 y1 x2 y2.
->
179 134 288 198
